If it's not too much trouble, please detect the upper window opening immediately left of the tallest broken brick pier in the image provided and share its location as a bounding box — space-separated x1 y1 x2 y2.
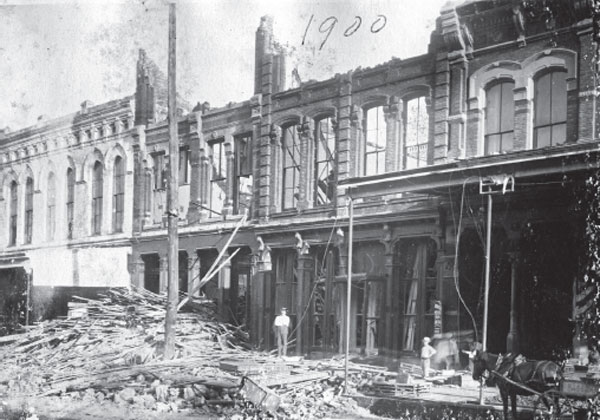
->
234 134 252 214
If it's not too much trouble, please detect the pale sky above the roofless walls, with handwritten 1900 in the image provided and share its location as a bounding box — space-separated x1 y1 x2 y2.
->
0 0 447 131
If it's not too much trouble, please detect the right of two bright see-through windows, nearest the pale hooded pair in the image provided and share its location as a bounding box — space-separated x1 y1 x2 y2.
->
403 96 429 169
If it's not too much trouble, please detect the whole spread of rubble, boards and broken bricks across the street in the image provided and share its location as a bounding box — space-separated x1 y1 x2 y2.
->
0 290 372 419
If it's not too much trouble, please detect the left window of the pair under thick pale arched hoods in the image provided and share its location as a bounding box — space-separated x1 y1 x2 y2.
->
484 80 515 155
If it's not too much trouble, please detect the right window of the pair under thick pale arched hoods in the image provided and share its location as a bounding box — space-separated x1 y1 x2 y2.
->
533 70 567 148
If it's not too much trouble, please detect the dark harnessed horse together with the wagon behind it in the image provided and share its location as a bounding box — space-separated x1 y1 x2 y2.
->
473 352 600 420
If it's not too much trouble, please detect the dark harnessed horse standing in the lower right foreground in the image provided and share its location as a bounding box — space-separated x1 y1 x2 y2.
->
473 352 563 420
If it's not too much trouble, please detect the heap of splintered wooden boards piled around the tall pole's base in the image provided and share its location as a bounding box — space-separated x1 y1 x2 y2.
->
0 289 247 395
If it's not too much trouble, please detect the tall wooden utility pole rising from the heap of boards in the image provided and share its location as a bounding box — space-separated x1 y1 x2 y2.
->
165 3 179 359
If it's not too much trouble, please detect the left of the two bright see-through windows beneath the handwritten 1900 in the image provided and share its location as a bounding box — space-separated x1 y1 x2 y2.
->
364 106 387 175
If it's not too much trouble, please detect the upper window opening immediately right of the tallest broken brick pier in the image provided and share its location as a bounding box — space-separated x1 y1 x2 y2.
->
281 124 300 209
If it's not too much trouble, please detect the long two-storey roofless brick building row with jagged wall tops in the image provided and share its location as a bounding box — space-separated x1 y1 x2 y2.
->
0 0 598 355
